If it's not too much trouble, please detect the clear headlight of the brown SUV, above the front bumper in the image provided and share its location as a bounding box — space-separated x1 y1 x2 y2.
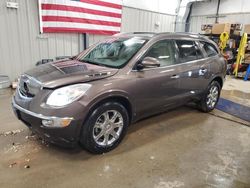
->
46 84 91 107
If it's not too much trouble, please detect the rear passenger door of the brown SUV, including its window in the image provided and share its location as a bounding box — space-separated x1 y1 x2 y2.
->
175 40 210 102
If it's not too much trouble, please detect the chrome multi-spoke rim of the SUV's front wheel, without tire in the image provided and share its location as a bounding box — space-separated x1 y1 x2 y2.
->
93 110 124 146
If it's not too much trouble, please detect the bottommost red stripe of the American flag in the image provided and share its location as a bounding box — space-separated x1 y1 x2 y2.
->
43 27 118 35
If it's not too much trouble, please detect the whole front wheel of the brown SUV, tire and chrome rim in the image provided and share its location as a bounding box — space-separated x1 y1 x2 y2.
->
80 102 129 154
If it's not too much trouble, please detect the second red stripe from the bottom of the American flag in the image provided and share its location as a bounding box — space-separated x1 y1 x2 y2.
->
42 16 121 27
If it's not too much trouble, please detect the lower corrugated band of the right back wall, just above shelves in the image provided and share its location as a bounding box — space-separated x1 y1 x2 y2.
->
190 13 250 33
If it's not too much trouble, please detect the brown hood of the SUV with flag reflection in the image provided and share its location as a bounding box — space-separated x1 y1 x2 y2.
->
25 60 118 88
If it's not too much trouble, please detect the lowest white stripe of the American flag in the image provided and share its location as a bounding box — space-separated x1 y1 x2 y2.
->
43 22 120 32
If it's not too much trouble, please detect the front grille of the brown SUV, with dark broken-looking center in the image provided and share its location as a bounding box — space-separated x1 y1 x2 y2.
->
18 75 41 98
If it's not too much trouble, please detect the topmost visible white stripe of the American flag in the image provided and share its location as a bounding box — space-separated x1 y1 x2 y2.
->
42 0 122 14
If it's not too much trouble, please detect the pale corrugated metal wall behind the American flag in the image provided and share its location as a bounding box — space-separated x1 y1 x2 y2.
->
0 0 175 80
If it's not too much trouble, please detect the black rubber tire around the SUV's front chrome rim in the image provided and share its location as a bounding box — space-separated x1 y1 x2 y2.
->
80 101 129 154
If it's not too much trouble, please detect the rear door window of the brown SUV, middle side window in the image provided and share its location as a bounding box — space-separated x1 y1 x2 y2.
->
176 40 203 63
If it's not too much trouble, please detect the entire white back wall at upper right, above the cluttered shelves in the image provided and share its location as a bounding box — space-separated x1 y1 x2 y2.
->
190 0 250 33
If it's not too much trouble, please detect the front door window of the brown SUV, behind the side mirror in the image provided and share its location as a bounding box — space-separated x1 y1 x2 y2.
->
144 40 176 67
